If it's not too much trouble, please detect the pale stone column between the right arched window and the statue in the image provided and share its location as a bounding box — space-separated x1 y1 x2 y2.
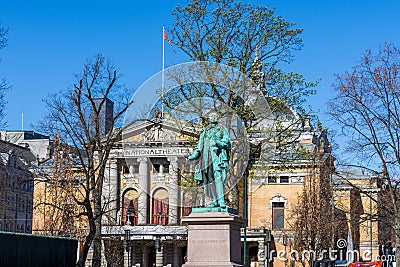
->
168 157 180 224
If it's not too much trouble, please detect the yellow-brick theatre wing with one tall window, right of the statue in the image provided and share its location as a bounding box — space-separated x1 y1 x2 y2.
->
248 129 334 267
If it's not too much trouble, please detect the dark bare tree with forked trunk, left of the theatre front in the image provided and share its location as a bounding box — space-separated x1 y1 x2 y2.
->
41 55 131 266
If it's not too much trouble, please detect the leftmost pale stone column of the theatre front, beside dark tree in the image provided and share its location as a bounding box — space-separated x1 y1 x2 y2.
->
102 159 119 224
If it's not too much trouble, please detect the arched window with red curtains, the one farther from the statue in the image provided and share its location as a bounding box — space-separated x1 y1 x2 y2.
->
122 189 139 225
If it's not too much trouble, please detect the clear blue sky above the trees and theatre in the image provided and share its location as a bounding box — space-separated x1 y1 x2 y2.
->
0 0 400 139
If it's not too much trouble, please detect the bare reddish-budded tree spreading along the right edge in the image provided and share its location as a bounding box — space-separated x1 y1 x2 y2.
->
329 43 400 265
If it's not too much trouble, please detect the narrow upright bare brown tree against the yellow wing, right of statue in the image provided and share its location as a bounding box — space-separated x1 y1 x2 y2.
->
289 151 342 266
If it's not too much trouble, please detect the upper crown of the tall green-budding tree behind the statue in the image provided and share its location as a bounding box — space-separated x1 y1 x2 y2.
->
171 0 316 114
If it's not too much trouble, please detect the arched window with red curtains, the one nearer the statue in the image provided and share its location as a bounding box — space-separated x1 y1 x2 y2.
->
152 188 169 225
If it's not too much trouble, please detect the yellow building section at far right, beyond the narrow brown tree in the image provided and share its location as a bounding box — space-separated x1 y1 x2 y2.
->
333 170 383 260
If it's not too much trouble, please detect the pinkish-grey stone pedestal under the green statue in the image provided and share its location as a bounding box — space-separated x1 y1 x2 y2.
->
182 212 244 267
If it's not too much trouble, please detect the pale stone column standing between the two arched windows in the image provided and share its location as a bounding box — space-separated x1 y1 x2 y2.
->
138 157 150 224
